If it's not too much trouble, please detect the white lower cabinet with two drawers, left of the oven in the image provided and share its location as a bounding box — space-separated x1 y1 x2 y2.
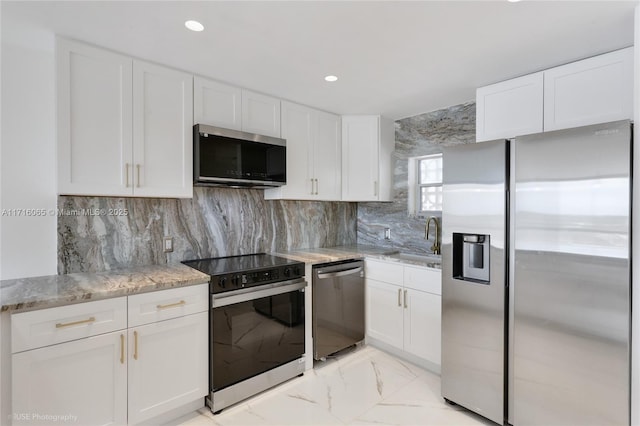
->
10 284 209 425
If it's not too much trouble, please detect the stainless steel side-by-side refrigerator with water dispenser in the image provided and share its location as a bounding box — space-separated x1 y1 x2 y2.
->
441 121 632 426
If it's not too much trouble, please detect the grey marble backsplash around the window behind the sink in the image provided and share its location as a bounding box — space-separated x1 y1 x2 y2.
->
357 102 476 254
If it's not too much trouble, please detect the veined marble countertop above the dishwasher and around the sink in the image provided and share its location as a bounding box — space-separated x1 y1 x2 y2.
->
274 245 441 269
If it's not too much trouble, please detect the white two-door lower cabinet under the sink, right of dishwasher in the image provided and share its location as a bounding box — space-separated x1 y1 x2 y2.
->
365 259 441 366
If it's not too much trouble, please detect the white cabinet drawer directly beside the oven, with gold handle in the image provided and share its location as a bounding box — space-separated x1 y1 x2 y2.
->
129 284 209 327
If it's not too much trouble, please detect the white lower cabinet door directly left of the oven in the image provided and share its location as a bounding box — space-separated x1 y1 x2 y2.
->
129 312 209 424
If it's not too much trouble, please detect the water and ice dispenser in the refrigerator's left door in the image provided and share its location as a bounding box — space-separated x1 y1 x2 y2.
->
453 233 491 284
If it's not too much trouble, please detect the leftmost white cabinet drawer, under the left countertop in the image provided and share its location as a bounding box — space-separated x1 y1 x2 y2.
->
11 297 127 353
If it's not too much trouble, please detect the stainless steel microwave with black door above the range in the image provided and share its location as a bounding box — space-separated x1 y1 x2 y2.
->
193 124 287 188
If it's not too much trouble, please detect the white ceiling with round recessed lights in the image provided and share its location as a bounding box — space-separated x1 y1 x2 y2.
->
1 0 638 119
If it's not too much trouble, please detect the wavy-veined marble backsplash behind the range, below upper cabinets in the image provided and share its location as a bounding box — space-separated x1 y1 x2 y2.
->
58 187 357 274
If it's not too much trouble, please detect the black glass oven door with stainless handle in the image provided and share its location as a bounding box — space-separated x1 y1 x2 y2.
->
210 279 307 392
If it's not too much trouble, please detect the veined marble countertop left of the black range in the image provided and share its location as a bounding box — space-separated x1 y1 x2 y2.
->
0 264 209 312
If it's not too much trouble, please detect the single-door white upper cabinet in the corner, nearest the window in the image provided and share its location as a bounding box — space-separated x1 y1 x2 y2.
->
342 115 395 201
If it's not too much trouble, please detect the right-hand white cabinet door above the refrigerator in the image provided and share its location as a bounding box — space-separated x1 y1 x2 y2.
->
544 47 633 131
